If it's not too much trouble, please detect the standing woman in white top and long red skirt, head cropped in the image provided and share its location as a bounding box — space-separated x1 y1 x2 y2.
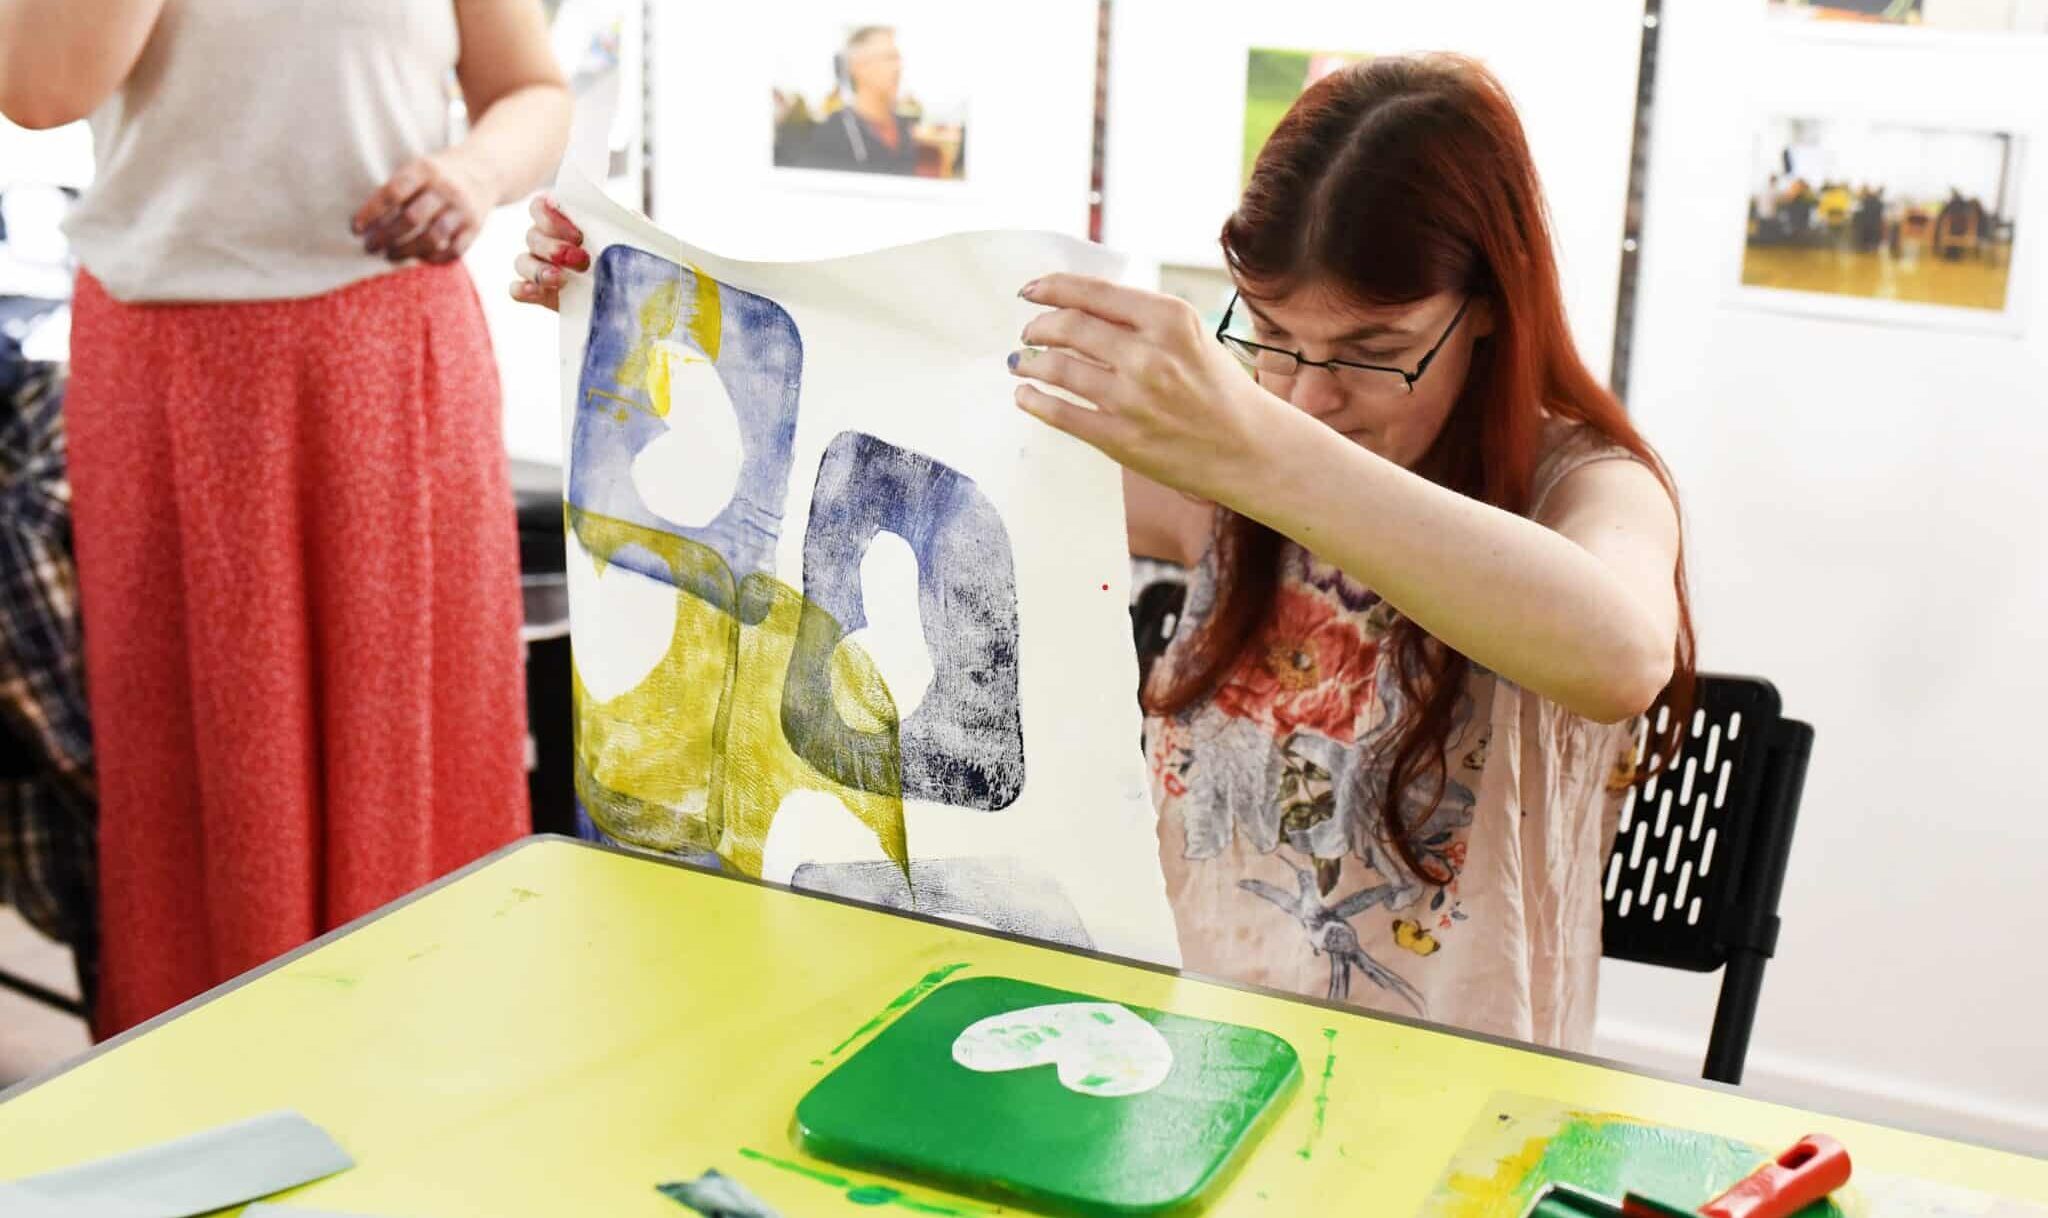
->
0 0 569 1036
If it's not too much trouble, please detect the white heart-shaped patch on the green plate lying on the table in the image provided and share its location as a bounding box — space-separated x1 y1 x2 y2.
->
952 1003 1174 1099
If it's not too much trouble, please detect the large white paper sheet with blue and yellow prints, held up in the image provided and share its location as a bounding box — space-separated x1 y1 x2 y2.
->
557 174 1180 964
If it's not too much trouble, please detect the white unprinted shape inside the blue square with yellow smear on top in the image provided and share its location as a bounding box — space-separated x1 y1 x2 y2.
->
633 342 741 528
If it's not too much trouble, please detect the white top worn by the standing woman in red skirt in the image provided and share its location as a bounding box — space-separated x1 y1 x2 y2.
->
66 0 461 303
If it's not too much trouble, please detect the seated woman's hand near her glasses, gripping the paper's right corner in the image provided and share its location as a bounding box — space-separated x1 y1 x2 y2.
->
1010 274 1290 504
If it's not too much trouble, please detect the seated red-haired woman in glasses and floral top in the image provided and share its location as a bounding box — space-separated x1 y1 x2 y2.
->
1012 57 1692 1046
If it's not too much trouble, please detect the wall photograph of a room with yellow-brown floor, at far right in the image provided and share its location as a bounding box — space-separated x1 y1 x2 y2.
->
1741 117 2025 330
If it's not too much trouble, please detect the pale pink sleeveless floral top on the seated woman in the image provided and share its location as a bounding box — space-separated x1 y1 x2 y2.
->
1145 426 1636 1048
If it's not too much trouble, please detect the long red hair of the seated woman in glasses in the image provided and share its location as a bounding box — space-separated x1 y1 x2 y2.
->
1145 55 1694 882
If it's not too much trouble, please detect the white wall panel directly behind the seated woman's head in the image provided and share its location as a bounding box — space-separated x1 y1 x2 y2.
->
1104 0 1646 377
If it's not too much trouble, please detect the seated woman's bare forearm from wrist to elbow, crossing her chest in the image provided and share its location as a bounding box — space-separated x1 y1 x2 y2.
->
1233 411 1675 721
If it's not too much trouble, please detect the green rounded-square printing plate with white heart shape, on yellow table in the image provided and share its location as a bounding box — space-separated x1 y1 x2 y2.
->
797 976 1300 1216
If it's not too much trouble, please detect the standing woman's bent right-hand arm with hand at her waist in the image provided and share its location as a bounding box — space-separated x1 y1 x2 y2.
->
354 0 573 262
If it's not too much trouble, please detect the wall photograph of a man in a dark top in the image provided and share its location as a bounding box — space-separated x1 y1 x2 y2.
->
772 20 973 186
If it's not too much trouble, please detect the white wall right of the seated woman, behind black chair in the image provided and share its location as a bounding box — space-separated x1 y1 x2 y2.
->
1599 0 2048 1152
